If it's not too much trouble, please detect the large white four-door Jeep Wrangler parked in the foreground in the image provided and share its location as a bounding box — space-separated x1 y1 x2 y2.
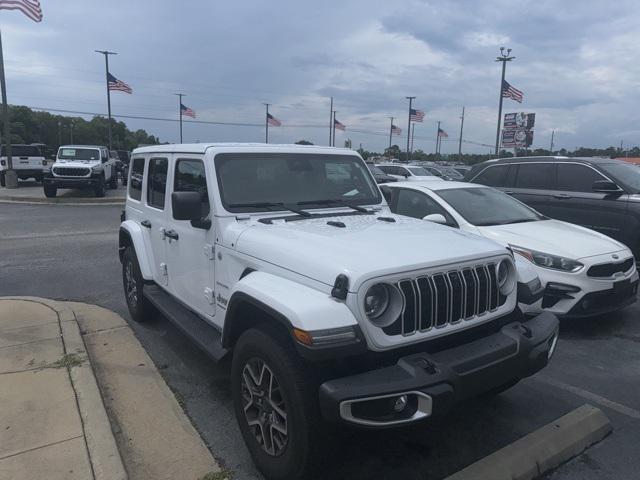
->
119 144 558 479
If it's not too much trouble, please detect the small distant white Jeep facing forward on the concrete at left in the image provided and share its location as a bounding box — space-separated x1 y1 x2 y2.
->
42 145 118 197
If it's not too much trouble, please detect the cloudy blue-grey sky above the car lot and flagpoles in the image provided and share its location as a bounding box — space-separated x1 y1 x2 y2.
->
5 0 640 153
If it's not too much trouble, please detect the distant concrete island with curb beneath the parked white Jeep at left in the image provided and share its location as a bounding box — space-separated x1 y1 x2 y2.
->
0 180 127 205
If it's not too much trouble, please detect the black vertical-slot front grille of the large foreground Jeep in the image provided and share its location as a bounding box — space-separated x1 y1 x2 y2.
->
383 263 506 336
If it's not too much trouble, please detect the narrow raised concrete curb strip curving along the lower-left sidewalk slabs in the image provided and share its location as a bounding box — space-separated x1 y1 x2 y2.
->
3 297 128 480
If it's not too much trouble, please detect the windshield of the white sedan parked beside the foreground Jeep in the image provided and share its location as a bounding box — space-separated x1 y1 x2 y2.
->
437 188 545 227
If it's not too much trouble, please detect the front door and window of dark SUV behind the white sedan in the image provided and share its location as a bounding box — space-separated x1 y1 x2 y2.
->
545 162 633 244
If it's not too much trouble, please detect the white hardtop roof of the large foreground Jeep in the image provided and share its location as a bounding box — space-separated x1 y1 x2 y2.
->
132 143 357 155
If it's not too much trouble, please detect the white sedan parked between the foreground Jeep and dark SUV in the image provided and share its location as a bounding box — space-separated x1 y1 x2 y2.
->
382 181 638 317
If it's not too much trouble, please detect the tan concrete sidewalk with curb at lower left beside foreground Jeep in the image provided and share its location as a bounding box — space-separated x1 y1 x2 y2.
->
0 297 222 480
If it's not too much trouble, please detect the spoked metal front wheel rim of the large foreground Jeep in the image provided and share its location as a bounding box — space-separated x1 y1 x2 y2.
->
241 358 288 457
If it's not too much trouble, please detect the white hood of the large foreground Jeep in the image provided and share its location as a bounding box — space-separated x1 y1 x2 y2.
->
235 213 506 291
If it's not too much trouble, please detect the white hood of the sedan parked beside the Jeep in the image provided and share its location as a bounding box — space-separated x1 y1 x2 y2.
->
477 220 627 260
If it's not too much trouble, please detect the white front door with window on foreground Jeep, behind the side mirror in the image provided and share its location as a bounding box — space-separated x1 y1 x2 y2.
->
166 154 215 317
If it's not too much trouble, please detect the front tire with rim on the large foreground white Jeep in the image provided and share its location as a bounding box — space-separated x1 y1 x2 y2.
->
231 325 323 480
